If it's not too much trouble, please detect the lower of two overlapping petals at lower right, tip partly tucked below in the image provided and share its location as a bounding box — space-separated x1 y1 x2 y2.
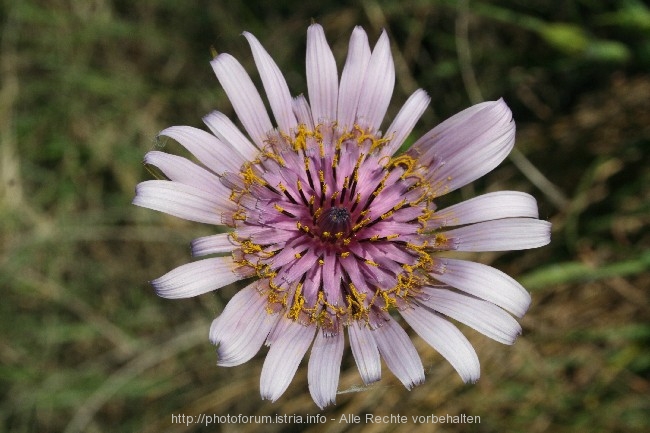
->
418 287 521 344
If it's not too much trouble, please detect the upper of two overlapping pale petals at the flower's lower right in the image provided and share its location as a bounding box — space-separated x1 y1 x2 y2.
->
431 257 530 317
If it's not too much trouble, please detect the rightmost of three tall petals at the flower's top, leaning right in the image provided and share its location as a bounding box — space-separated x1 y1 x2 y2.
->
357 31 395 131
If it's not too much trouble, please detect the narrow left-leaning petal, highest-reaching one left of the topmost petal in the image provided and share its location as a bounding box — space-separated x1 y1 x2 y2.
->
244 32 298 134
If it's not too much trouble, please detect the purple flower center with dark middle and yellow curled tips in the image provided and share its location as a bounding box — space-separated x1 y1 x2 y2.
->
222 125 431 329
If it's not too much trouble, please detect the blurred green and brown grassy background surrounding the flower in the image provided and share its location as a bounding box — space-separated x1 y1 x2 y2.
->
0 0 650 432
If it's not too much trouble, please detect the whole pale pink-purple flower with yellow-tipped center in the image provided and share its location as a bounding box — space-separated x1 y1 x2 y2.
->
133 24 550 408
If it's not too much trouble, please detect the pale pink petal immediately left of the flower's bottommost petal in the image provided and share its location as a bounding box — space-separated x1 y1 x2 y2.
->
260 318 316 402
